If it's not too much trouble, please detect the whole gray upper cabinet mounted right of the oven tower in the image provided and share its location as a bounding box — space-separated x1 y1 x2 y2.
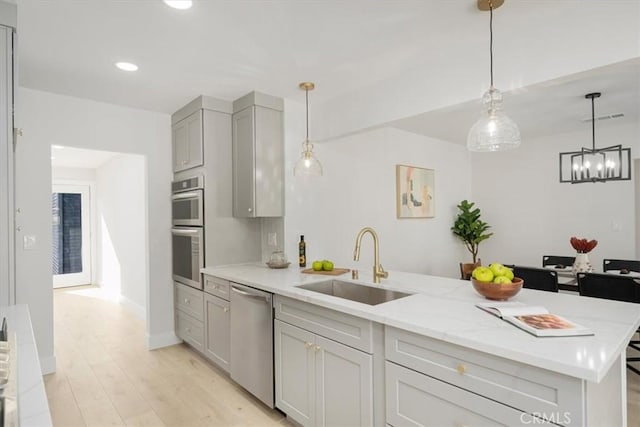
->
233 92 284 218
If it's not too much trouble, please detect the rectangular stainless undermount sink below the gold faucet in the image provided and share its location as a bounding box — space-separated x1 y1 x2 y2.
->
297 280 413 305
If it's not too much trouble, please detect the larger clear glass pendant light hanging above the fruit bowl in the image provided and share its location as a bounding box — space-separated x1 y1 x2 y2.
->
467 0 520 151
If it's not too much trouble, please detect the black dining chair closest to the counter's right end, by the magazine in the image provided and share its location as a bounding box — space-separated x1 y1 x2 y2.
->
578 273 640 375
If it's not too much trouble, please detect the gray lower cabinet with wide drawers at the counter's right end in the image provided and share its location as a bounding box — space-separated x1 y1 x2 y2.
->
385 326 584 427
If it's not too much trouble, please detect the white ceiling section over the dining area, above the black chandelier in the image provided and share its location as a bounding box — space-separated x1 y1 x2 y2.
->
390 58 640 146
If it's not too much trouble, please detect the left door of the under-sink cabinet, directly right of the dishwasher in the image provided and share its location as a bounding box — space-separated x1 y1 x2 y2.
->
274 320 315 426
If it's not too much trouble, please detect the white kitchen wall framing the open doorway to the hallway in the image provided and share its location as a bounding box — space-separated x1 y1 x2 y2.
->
16 88 176 372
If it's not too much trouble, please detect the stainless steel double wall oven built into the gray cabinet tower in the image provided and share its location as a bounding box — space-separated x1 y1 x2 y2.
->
171 175 204 289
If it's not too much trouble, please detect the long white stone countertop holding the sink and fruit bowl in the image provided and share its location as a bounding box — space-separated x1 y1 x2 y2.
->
201 264 640 382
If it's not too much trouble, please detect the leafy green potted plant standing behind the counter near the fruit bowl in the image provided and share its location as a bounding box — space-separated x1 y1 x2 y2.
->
451 200 493 280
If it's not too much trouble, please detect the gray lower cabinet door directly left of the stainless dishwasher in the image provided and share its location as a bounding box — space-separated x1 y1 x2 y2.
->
204 294 230 372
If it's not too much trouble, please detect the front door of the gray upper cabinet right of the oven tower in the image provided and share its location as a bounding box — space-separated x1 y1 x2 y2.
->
233 107 256 218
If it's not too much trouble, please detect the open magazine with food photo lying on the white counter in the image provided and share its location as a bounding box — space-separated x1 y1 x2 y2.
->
476 302 593 337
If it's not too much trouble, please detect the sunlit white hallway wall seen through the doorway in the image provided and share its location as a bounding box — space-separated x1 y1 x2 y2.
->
96 154 148 318
